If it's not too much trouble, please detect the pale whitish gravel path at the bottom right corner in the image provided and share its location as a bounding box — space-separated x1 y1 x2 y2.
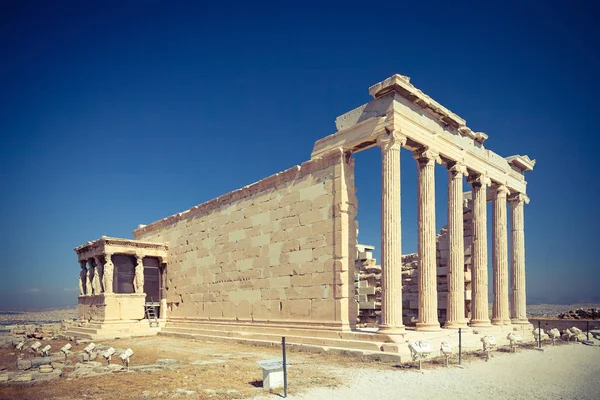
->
271 341 600 400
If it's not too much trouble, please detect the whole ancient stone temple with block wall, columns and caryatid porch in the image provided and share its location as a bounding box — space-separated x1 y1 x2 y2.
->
69 75 535 352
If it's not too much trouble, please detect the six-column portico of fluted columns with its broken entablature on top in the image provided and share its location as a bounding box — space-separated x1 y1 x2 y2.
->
311 75 535 334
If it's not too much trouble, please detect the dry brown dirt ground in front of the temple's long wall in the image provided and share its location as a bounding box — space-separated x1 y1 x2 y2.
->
0 336 584 400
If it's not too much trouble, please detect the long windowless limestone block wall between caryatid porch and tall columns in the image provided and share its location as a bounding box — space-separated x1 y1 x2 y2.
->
134 151 357 328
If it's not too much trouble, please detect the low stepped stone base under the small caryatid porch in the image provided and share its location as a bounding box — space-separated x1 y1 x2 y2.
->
63 319 166 340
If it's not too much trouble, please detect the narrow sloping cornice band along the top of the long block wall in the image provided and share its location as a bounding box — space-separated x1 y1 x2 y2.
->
133 148 345 237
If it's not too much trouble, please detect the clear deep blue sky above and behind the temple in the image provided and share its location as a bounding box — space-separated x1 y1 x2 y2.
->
0 0 600 309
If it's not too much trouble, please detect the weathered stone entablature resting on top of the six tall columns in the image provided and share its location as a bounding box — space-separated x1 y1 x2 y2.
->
311 75 535 193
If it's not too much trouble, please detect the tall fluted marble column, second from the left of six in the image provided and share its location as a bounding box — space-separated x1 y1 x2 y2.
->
413 149 440 331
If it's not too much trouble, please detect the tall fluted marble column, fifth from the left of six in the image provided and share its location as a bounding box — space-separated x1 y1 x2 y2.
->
492 185 510 325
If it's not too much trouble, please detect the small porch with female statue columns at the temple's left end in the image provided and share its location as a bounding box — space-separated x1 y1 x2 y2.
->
75 236 167 321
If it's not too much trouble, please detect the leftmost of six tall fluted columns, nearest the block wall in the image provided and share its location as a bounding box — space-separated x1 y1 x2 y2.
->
377 131 406 334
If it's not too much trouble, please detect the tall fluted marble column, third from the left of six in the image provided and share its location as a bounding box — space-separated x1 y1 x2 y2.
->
444 162 467 329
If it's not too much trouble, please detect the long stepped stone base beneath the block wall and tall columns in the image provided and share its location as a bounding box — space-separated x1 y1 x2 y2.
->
159 320 533 362
